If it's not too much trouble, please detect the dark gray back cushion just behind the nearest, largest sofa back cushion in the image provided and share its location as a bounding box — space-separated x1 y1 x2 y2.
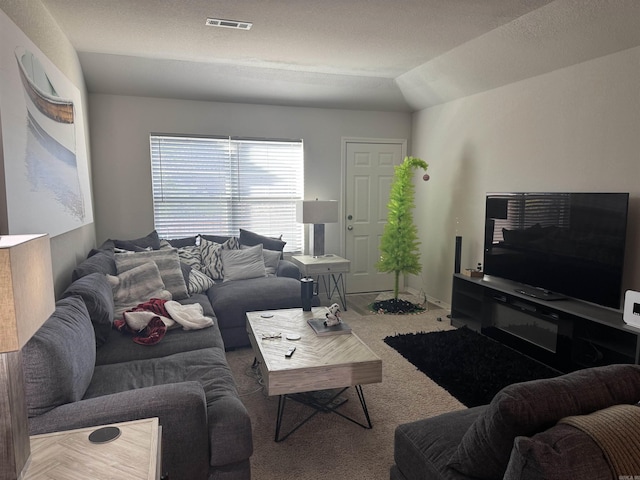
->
62 273 114 347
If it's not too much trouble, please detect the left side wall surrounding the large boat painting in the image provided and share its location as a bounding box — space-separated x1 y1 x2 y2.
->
0 0 95 295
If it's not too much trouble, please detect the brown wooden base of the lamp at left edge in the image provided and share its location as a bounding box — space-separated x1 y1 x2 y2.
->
0 350 31 480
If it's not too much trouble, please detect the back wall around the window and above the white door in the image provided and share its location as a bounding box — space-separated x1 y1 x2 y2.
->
89 94 411 252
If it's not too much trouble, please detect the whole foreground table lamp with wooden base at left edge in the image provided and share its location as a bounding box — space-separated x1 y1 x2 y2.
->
0 235 55 480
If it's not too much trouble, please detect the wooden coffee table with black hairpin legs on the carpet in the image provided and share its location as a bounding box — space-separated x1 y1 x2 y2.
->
247 307 382 442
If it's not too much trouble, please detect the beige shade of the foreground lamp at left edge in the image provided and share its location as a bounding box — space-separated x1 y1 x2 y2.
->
0 235 55 352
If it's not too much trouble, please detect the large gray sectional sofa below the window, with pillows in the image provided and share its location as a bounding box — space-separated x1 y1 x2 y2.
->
22 232 318 480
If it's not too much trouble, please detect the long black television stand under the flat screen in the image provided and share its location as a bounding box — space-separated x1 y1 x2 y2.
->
451 274 640 372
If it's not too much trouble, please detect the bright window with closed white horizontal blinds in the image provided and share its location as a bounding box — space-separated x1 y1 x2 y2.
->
151 134 304 251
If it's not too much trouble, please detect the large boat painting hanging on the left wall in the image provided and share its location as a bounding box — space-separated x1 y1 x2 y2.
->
0 10 93 237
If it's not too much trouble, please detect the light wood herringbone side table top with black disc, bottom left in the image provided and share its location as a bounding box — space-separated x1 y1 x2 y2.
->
22 418 162 480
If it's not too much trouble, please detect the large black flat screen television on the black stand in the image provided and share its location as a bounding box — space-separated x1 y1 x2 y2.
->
483 192 629 309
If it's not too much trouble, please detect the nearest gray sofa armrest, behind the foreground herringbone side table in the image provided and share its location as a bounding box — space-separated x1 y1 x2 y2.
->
29 382 209 480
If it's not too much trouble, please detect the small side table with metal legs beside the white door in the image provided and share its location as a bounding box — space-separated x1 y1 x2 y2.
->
291 254 351 311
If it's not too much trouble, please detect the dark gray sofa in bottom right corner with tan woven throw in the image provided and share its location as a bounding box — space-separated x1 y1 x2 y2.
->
390 365 640 480
